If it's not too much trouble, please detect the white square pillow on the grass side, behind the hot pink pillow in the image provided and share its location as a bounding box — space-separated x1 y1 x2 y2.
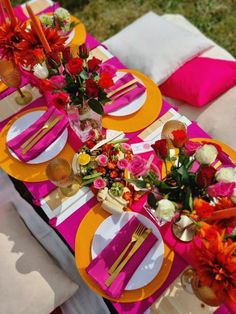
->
104 12 212 84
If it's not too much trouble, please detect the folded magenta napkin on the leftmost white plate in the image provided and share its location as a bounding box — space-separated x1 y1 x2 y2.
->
7 107 68 162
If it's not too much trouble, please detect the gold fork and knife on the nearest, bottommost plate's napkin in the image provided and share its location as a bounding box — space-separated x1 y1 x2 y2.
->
105 223 152 287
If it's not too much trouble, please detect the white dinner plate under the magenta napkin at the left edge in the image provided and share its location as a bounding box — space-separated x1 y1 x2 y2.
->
7 110 68 164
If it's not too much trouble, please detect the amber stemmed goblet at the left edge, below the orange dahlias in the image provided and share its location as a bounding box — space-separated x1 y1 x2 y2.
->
0 60 32 106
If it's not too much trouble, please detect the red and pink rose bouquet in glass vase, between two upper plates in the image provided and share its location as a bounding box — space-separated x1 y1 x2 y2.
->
34 45 116 142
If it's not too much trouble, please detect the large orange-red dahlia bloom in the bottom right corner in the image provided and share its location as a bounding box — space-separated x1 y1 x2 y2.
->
192 222 236 306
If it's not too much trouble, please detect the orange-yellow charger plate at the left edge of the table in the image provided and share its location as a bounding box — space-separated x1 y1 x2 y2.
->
0 107 75 182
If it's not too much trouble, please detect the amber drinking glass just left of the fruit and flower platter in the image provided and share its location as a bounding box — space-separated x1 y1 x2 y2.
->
46 158 81 196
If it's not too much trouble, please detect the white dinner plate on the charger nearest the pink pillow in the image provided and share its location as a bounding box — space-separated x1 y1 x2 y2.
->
108 72 147 117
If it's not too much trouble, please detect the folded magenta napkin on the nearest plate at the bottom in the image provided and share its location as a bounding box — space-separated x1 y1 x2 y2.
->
86 217 157 299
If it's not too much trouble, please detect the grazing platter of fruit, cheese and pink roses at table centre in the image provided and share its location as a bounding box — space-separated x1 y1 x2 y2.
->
74 138 159 213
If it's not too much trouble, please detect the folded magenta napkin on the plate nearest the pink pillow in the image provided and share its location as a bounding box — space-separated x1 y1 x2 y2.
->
103 73 146 114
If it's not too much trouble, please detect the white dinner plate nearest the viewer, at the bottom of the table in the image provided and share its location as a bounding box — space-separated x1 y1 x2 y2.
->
91 212 164 290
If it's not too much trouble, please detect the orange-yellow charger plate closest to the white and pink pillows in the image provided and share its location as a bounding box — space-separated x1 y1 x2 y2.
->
102 69 162 133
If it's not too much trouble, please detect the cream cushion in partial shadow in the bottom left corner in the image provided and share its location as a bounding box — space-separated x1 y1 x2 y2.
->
0 203 78 314
